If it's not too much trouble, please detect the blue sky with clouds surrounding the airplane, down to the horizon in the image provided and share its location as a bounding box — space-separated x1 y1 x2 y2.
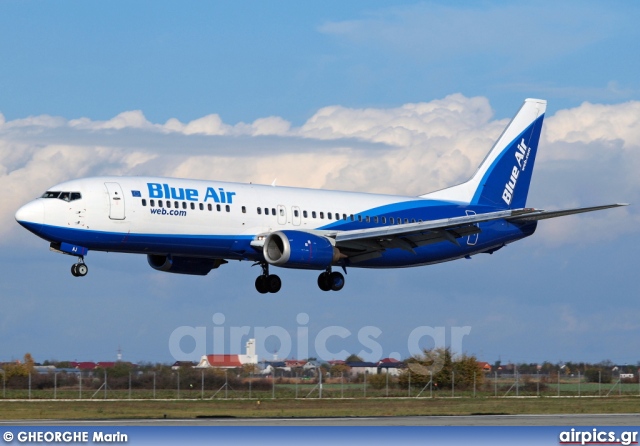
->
0 0 640 364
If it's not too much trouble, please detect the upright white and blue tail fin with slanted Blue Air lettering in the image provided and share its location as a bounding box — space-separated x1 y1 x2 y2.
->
421 99 547 209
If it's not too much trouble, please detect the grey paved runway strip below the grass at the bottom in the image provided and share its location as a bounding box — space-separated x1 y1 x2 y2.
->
0 414 640 426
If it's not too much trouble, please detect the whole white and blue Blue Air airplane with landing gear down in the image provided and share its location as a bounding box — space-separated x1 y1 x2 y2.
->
15 99 625 293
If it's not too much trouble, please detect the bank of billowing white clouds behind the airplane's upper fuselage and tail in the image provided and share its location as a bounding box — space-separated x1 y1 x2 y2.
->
0 94 640 244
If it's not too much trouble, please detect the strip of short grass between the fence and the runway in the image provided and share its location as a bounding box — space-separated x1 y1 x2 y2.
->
0 397 640 420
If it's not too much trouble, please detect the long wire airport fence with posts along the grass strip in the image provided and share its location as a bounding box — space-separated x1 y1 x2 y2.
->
1 370 640 400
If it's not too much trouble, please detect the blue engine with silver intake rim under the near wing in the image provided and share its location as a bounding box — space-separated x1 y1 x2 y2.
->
262 231 340 270
